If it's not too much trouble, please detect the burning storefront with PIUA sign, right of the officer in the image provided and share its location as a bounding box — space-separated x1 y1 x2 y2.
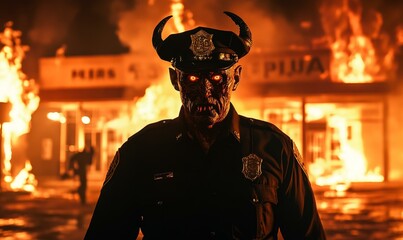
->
237 47 403 185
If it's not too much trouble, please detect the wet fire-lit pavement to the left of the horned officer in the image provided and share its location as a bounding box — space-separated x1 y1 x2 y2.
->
0 174 102 240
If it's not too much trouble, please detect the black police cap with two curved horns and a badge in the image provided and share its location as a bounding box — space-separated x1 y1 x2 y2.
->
152 12 252 71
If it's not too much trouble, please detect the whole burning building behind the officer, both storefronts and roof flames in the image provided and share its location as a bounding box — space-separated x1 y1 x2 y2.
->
21 1 403 188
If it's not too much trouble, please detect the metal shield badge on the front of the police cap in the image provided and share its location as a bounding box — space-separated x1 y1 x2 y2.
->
189 30 215 60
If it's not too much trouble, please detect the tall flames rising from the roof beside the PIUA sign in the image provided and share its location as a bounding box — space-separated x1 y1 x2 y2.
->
321 0 390 83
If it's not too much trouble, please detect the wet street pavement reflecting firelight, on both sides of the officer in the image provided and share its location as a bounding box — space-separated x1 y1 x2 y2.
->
0 176 403 240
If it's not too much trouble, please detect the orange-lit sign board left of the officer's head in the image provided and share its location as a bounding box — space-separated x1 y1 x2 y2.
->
40 54 168 89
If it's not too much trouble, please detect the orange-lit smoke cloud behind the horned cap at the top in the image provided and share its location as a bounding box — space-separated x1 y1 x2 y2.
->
118 0 310 56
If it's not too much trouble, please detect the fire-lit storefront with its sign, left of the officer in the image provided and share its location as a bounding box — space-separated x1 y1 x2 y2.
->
30 54 168 176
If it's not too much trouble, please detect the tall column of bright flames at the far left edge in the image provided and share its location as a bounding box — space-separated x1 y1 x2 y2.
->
0 22 39 191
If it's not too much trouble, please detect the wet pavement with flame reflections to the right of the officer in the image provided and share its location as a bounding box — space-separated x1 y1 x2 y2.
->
316 183 403 240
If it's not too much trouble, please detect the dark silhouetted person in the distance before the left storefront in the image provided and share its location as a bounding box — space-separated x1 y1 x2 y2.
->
69 146 94 204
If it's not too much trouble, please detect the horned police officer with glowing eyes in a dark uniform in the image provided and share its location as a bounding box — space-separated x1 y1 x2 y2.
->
85 12 325 240
